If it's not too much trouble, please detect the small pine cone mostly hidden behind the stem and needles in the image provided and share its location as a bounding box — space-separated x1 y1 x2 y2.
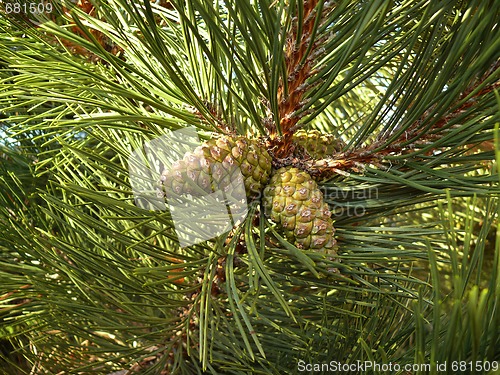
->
293 129 345 158
